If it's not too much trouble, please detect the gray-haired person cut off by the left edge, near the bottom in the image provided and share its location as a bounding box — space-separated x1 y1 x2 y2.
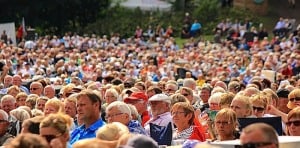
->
0 109 13 145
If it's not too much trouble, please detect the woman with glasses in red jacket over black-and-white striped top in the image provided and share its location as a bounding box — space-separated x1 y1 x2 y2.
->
171 102 205 141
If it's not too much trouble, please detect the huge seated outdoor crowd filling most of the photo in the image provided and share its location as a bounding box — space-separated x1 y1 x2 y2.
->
0 15 300 148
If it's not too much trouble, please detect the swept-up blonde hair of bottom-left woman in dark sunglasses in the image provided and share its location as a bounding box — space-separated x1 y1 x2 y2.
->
40 113 72 134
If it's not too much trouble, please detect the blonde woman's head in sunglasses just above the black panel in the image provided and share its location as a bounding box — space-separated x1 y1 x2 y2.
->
250 93 268 118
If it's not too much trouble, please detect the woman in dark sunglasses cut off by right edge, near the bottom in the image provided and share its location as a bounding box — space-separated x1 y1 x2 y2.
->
286 107 300 136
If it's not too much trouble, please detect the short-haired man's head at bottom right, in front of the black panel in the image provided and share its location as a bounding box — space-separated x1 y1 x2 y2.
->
240 123 279 148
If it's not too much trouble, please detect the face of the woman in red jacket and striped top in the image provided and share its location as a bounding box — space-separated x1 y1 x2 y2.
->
171 108 192 127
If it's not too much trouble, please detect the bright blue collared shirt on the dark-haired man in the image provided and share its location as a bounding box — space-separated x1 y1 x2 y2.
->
70 119 105 145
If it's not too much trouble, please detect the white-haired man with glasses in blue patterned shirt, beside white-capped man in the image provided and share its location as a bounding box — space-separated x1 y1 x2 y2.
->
105 101 146 135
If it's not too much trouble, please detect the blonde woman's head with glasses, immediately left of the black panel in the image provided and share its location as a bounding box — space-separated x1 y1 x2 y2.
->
214 108 239 141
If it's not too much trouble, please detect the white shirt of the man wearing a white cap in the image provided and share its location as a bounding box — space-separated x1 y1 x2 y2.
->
144 112 172 135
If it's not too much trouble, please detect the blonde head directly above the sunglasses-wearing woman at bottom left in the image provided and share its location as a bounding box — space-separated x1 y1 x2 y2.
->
44 99 65 116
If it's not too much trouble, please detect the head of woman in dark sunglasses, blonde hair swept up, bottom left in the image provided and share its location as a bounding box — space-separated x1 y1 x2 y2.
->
40 114 72 148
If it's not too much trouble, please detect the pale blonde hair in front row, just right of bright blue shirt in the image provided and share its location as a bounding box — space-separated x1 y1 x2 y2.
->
96 122 129 141
